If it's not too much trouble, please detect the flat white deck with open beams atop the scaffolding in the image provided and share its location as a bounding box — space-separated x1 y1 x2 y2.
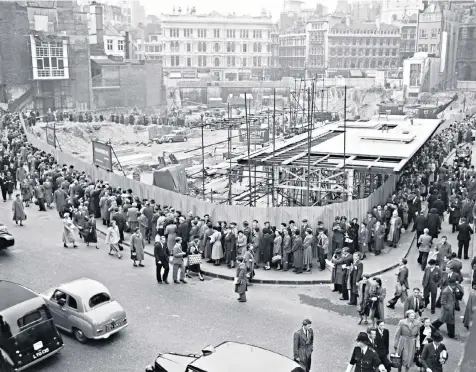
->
237 116 441 174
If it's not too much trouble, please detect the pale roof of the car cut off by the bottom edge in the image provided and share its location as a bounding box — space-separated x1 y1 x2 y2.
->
190 341 300 372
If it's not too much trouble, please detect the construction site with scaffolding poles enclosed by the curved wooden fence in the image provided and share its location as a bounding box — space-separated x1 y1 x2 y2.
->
31 80 474 206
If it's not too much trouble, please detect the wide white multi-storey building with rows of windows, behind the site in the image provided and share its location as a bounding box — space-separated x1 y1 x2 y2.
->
161 8 274 81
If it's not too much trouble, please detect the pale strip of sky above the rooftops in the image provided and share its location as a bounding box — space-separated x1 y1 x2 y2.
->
140 0 337 20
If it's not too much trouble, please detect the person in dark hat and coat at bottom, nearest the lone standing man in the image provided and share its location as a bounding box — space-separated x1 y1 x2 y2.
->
345 332 387 372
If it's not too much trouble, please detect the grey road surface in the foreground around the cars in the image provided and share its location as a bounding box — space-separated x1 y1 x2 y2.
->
0 192 467 372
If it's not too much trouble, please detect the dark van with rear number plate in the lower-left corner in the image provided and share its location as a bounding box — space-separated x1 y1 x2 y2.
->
0 280 64 372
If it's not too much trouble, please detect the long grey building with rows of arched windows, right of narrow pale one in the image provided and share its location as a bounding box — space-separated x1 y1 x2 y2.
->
327 18 401 76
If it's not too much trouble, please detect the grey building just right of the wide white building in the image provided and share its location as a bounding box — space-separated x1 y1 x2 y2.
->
279 24 308 78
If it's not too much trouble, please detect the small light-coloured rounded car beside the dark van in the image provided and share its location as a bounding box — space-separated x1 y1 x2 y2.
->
41 278 129 343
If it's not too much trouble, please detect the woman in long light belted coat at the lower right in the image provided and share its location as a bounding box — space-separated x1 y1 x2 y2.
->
394 310 421 372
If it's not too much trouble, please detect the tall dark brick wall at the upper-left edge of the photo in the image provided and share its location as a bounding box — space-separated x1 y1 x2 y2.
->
0 1 32 102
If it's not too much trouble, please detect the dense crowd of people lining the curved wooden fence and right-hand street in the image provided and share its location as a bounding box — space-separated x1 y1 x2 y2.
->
0 107 476 370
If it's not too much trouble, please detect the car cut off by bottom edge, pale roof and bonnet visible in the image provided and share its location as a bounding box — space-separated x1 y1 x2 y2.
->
145 341 304 372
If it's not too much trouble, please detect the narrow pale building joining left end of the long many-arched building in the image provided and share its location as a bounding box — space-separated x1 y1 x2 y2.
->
306 18 329 76
